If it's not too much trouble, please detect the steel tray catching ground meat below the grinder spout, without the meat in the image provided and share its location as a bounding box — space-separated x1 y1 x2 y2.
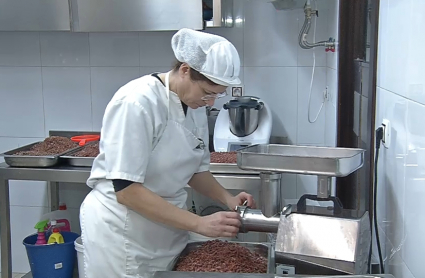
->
167 241 276 273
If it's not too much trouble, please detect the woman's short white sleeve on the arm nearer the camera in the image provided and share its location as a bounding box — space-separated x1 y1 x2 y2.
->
101 100 154 183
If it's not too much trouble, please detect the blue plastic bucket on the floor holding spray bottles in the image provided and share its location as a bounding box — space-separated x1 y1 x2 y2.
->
22 232 79 278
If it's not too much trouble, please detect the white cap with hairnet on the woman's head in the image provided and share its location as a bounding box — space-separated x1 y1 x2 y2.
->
171 28 241 86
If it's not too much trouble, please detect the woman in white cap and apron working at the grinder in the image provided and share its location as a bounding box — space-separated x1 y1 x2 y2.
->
80 29 255 278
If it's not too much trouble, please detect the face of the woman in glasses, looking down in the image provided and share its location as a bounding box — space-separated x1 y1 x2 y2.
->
178 66 227 109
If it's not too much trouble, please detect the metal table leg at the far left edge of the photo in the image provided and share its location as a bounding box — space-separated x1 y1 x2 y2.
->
0 180 12 278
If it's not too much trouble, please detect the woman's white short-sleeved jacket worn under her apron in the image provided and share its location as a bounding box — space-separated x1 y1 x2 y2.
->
87 75 210 187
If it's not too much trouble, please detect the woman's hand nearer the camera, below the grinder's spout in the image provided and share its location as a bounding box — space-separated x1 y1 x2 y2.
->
195 211 241 237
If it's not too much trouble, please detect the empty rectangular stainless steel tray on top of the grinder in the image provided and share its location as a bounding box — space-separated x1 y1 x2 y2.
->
237 144 365 177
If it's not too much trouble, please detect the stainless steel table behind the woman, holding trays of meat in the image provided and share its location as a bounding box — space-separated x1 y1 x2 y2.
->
0 163 261 278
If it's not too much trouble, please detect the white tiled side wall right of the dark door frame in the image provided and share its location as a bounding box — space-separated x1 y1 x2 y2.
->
375 0 425 278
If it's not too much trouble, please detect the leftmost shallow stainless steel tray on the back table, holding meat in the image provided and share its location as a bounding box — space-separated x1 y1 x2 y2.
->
0 141 80 168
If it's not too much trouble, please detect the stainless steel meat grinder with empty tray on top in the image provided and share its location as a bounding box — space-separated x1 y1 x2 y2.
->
236 144 371 274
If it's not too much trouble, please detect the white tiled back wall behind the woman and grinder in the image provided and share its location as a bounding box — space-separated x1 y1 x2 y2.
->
0 0 338 272
